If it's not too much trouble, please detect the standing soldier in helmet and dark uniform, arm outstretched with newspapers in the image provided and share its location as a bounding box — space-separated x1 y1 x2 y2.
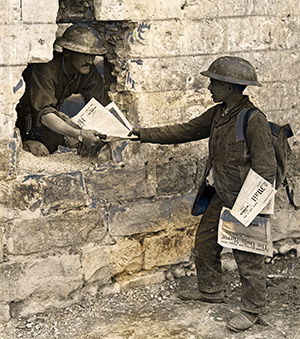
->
133 56 277 331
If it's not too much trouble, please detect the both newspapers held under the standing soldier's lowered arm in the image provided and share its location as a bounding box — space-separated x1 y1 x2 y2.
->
218 169 276 255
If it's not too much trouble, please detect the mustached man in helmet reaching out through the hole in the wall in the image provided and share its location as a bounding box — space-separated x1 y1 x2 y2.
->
16 24 109 156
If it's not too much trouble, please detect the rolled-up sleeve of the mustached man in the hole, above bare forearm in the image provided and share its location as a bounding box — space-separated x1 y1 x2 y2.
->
30 64 58 126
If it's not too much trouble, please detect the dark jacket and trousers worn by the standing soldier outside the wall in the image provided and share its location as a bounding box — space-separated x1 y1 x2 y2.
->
140 96 276 313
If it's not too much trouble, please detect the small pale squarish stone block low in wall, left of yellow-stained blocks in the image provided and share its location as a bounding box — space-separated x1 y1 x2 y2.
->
81 244 112 285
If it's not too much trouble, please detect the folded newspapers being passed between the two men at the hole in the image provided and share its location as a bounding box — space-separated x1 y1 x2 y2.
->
72 98 136 141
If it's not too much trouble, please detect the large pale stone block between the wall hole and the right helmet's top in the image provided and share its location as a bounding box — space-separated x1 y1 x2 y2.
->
117 19 227 59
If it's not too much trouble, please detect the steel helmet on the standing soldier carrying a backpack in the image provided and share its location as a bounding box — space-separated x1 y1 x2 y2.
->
201 56 261 86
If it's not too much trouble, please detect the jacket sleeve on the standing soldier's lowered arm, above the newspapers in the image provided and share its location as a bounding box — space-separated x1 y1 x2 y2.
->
246 113 277 184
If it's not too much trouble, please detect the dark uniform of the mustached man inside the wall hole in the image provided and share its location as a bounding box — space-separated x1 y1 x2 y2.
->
16 53 110 153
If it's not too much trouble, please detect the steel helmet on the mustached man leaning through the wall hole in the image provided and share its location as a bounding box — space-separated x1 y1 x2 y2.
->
55 24 106 55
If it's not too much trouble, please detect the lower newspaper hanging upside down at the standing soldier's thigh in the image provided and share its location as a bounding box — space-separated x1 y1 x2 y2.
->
218 207 273 256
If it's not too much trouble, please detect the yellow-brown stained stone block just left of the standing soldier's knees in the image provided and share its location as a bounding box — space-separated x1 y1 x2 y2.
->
143 230 194 270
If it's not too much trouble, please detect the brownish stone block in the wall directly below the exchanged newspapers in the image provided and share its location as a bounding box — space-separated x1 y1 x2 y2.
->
85 165 155 203
